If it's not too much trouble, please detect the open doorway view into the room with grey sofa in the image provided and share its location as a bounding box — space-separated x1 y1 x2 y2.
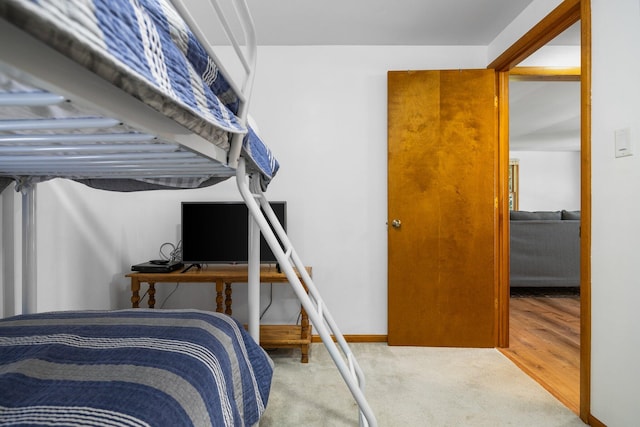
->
501 61 581 413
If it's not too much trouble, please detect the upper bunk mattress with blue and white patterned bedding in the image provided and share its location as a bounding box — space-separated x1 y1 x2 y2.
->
0 0 279 190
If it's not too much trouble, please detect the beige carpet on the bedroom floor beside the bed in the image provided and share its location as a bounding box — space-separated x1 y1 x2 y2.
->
260 343 584 427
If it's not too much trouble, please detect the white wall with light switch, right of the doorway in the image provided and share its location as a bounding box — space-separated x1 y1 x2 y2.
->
591 0 640 427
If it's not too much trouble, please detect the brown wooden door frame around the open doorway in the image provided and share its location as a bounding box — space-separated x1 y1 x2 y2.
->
487 0 593 423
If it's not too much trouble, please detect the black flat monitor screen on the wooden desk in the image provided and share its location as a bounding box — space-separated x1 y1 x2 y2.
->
182 202 287 264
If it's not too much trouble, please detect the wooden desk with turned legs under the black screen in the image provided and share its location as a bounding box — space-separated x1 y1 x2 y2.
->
126 265 311 363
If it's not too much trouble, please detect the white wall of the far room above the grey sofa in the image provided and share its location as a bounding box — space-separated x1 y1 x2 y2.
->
510 151 580 211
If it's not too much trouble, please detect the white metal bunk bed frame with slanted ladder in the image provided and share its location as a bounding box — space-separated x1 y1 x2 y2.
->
0 0 377 426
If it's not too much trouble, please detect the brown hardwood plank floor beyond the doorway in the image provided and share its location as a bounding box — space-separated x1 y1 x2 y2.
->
501 295 580 414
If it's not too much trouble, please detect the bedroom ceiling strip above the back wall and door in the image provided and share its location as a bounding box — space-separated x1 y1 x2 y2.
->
247 0 533 46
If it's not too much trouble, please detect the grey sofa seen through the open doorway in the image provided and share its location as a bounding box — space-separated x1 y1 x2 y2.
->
509 210 580 287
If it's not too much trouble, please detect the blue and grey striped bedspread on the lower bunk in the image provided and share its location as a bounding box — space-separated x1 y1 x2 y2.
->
0 309 273 426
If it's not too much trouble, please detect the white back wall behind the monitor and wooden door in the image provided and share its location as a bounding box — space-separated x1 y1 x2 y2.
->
0 47 487 334
